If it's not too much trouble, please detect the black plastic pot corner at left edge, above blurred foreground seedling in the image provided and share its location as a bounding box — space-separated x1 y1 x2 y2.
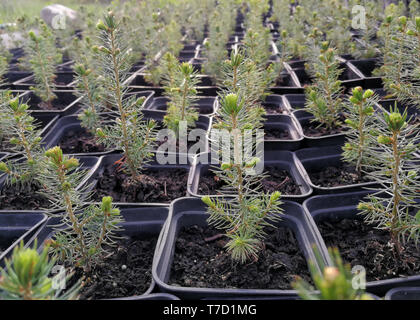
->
0 211 47 267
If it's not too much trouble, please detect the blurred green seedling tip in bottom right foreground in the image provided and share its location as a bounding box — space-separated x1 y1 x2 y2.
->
293 248 372 300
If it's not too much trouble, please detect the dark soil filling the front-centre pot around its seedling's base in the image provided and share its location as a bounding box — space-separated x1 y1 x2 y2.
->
169 226 310 290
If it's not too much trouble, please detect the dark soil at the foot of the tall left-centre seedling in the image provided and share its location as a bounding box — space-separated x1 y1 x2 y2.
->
93 164 188 202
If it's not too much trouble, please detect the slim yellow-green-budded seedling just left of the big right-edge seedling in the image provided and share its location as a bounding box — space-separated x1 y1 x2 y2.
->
343 87 379 177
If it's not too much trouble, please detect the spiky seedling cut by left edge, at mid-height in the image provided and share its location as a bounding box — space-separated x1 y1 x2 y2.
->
0 98 42 184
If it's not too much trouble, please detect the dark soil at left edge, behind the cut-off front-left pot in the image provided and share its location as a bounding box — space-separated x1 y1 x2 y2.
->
0 184 50 210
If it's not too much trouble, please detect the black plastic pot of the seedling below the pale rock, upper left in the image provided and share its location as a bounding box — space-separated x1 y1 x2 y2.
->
19 90 81 116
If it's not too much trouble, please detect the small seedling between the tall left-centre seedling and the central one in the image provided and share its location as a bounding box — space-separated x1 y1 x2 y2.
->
163 62 198 136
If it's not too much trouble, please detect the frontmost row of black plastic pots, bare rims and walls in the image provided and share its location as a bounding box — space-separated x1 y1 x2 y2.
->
0 191 420 300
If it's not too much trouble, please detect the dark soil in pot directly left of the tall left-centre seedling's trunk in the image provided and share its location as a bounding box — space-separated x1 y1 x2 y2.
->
59 129 105 153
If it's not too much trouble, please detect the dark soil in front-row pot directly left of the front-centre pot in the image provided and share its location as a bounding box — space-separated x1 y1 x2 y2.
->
75 238 157 300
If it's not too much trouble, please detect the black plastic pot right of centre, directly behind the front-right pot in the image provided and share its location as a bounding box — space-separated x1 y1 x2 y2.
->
295 146 377 194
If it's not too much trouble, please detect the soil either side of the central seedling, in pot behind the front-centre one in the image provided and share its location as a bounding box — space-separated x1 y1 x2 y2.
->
198 167 302 195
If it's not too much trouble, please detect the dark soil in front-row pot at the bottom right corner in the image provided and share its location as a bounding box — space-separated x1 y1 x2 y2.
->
318 219 420 281
